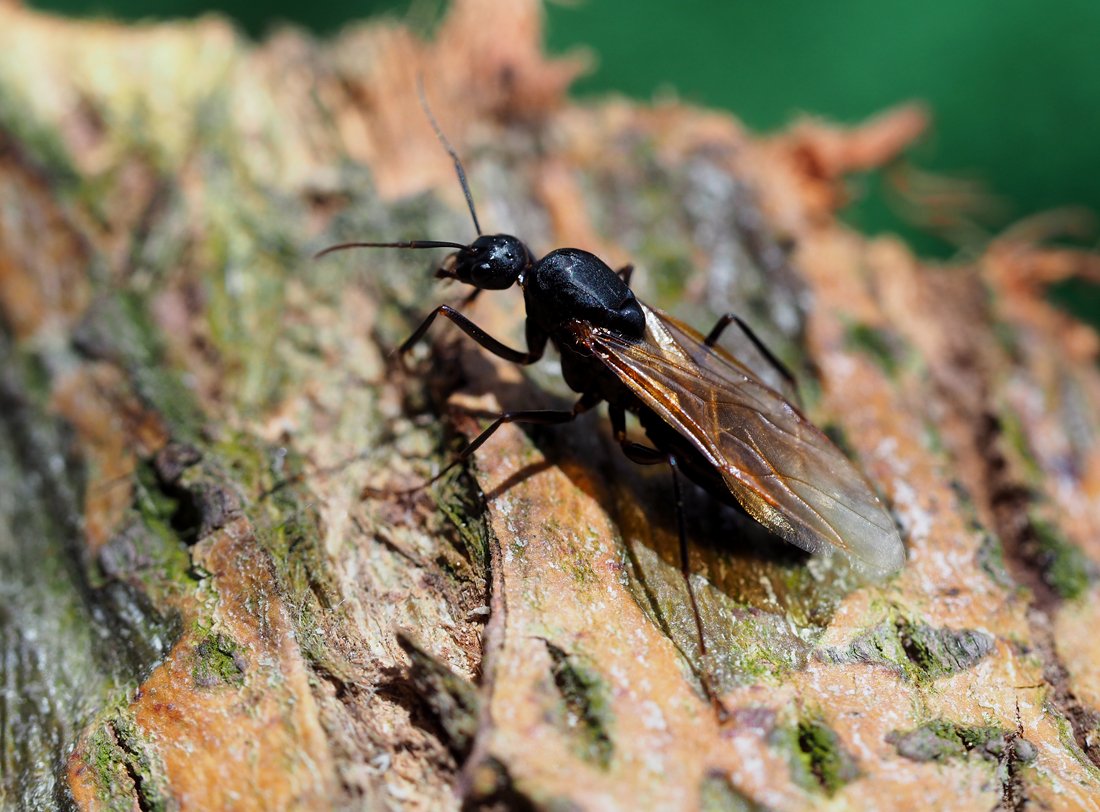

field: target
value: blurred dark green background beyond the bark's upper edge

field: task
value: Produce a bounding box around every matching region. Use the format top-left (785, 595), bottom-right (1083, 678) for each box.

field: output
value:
top-left (21, 0), bottom-right (1100, 320)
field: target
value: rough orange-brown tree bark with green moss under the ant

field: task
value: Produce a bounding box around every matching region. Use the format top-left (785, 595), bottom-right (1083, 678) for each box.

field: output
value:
top-left (0, 0), bottom-right (1100, 810)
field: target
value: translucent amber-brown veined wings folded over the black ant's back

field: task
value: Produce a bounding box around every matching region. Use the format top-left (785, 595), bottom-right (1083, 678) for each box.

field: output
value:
top-left (574, 308), bottom-right (904, 574)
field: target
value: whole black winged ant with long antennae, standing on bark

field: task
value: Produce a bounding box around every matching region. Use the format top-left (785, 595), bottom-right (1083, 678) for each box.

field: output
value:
top-left (317, 86), bottom-right (904, 712)
